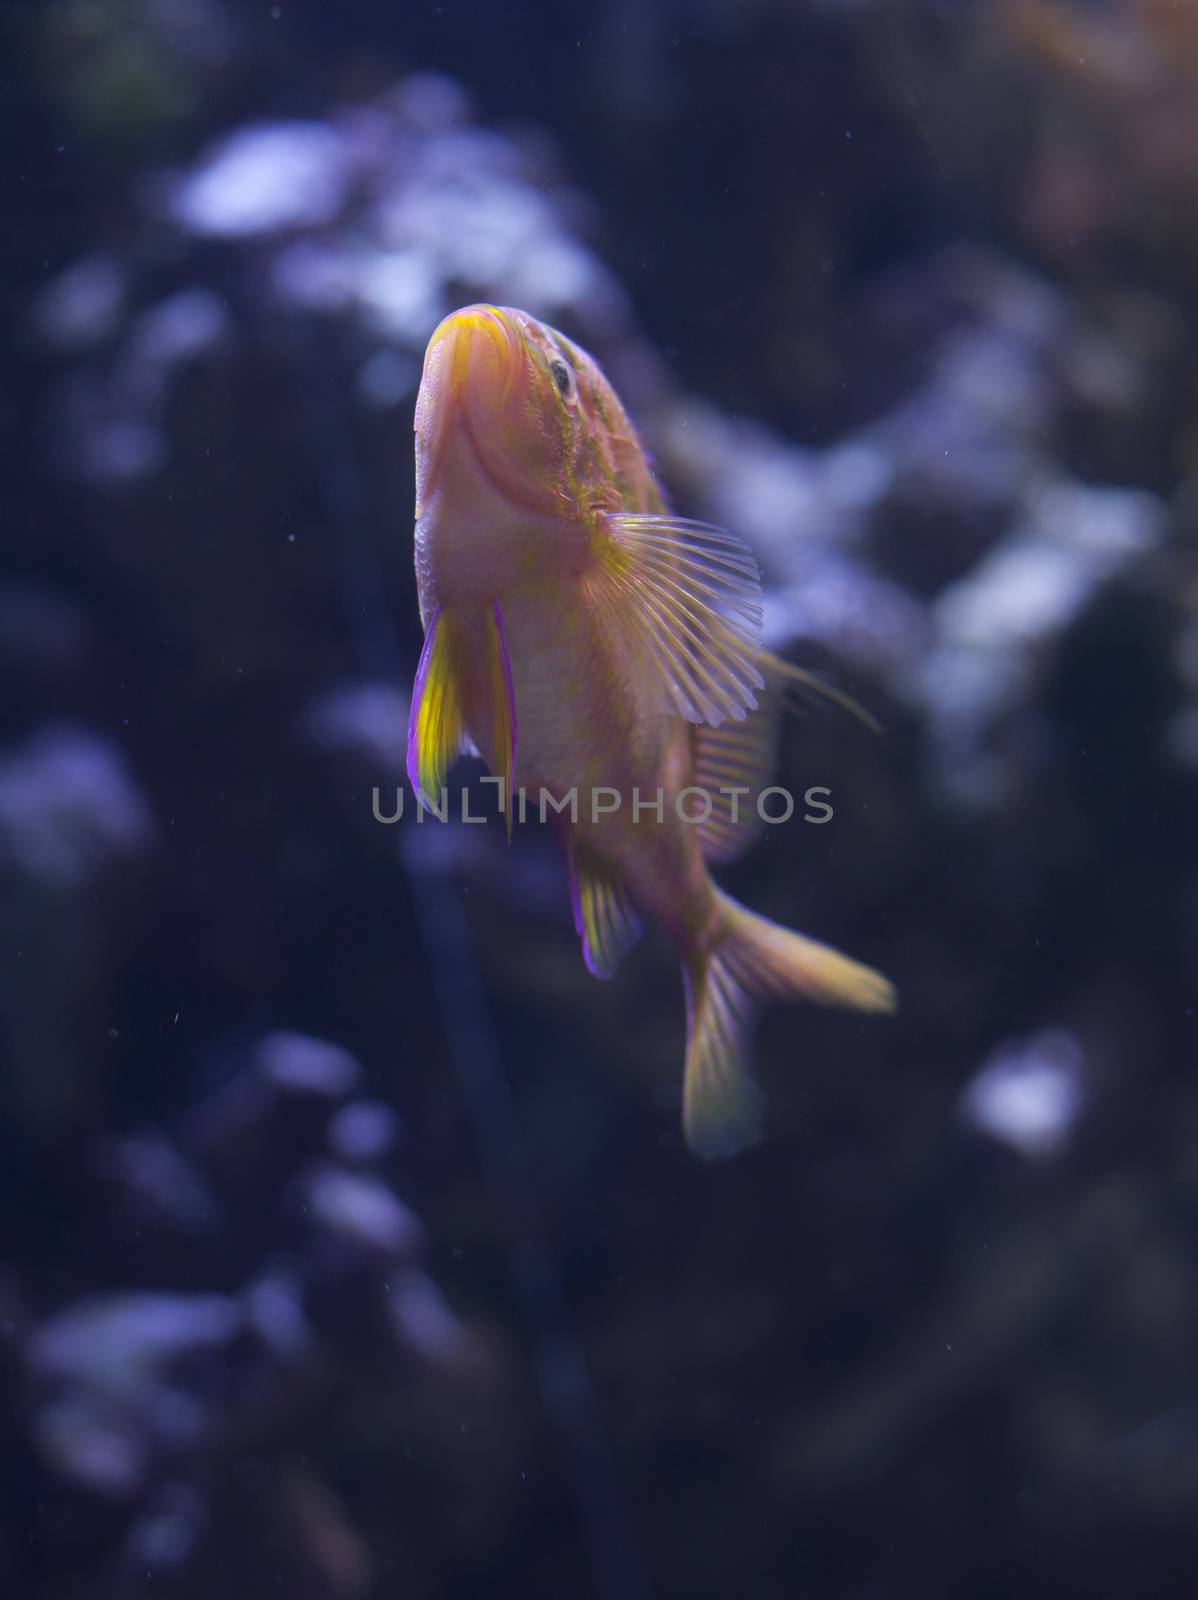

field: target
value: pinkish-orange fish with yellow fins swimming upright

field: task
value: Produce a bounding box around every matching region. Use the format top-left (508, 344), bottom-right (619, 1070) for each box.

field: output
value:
top-left (406, 304), bottom-right (896, 1160)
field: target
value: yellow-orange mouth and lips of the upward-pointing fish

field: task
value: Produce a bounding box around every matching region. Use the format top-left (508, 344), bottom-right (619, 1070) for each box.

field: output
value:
top-left (414, 306), bottom-right (526, 517)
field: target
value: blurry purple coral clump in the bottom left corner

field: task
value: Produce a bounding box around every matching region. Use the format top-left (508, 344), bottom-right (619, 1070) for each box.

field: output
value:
top-left (0, 1035), bottom-right (494, 1597)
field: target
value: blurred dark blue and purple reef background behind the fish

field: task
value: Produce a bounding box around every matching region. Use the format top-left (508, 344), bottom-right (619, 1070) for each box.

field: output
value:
top-left (0, 0), bottom-right (1198, 1600)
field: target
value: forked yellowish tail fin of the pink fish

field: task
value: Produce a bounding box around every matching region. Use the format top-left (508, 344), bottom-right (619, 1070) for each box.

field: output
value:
top-left (683, 890), bottom-right (896, 1160)
